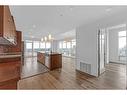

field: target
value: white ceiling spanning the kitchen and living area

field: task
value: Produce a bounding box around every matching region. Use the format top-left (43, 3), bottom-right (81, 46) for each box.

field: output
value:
top-left (10, 6), bottom-right (127, 39)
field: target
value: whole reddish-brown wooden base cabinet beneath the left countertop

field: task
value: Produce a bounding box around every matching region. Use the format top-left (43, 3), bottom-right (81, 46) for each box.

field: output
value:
top-left (0, 61), bottom-right (21, 89)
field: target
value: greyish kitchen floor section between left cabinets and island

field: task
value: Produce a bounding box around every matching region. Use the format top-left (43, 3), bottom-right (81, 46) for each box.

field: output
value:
top-left (21, 57), bottom-right (49, 78)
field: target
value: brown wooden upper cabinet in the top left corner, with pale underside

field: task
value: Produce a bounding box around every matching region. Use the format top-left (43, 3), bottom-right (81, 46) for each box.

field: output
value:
top-left (0, 6), bottom-right (17, 45)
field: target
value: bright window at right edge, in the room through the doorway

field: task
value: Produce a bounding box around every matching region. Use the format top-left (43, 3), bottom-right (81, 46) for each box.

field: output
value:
top-left (118, 31), bottom-right (127, 61)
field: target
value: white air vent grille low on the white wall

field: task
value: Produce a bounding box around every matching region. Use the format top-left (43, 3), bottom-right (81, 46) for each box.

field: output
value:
top-left (80, 62), bottom-right (91, 74)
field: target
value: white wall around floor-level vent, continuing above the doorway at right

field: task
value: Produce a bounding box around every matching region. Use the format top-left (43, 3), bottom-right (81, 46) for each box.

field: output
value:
top-left (76, 11), bottom-right (127, 76)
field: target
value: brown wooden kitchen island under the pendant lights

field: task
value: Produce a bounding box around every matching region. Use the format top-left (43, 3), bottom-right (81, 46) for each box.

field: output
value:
top-left (37, 51), bottom-right (62, 70)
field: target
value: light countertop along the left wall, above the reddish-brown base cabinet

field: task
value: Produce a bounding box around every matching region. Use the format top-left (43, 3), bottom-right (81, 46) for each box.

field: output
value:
top-left (0, 52), bottom-right (21, 58)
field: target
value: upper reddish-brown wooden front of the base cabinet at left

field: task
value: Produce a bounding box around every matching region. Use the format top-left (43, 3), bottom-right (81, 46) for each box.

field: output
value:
top-left (0, 61), bottom-right (21, 82)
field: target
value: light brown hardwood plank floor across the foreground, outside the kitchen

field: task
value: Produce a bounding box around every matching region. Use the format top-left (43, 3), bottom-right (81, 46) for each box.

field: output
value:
top-left (18, 57), bottom-right (126, 90)
